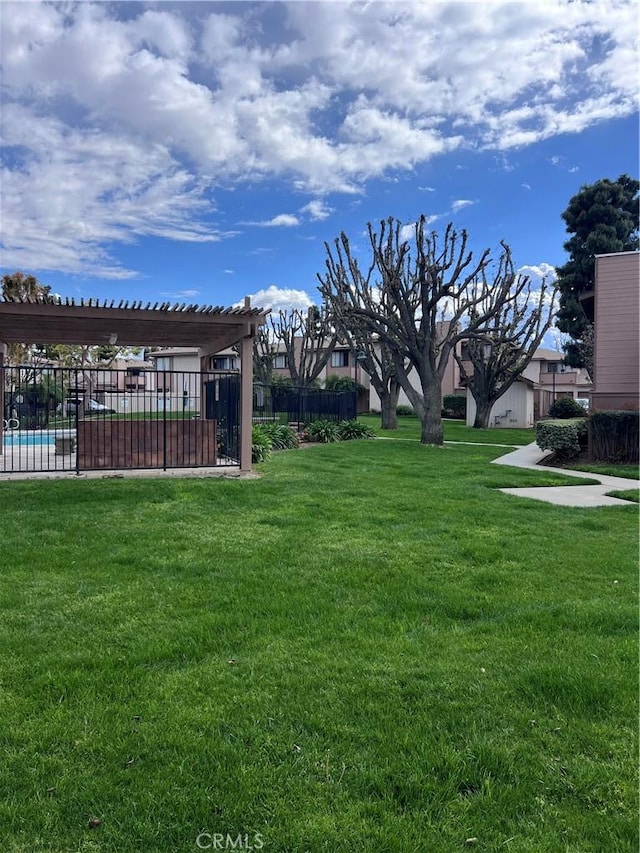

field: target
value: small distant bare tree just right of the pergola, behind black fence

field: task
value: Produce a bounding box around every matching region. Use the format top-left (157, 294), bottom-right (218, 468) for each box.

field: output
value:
top-left (268, 305), bottom-right (338, 388)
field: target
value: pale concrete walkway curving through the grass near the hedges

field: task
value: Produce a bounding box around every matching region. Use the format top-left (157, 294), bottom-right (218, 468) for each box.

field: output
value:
top-left (492, 443), bottom-right (640, 507)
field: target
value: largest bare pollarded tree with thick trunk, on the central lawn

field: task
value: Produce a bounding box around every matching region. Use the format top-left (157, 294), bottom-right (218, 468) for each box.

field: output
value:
top-left (319, 216), bottom-right (524, 444)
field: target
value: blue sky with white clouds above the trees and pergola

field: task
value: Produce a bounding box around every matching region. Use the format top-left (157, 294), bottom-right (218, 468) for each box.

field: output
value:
top-left (0, 0), bottom-right (638, 316)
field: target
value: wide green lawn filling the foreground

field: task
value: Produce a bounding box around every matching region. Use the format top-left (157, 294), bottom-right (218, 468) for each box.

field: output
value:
top-left (0, 441), bottom-right (638, 853)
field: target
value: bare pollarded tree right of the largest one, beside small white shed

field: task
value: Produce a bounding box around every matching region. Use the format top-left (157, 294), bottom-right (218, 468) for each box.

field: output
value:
top-left (454, 264), bottom-right (557, 429)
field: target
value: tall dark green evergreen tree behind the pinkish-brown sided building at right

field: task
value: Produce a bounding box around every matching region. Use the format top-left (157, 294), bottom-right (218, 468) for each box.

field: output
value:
top-left (556, 175), bottom-right (640, 368)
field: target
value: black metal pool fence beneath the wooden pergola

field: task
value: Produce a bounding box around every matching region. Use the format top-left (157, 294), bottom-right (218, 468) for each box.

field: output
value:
top-left (0, 365), bottom-right (240, 473)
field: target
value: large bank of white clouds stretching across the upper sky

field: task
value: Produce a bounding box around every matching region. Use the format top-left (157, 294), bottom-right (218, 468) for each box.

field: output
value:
top-left (0, 0), bottom-right (637, 278)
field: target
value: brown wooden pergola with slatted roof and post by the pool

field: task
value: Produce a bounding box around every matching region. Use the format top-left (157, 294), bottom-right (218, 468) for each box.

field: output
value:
top-left (0, 296), bottom-right (269, 471)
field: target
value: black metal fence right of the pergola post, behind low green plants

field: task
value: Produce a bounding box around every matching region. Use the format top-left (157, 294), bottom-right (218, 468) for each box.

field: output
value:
top-left (253, 385), bottom-right (356, 425)
